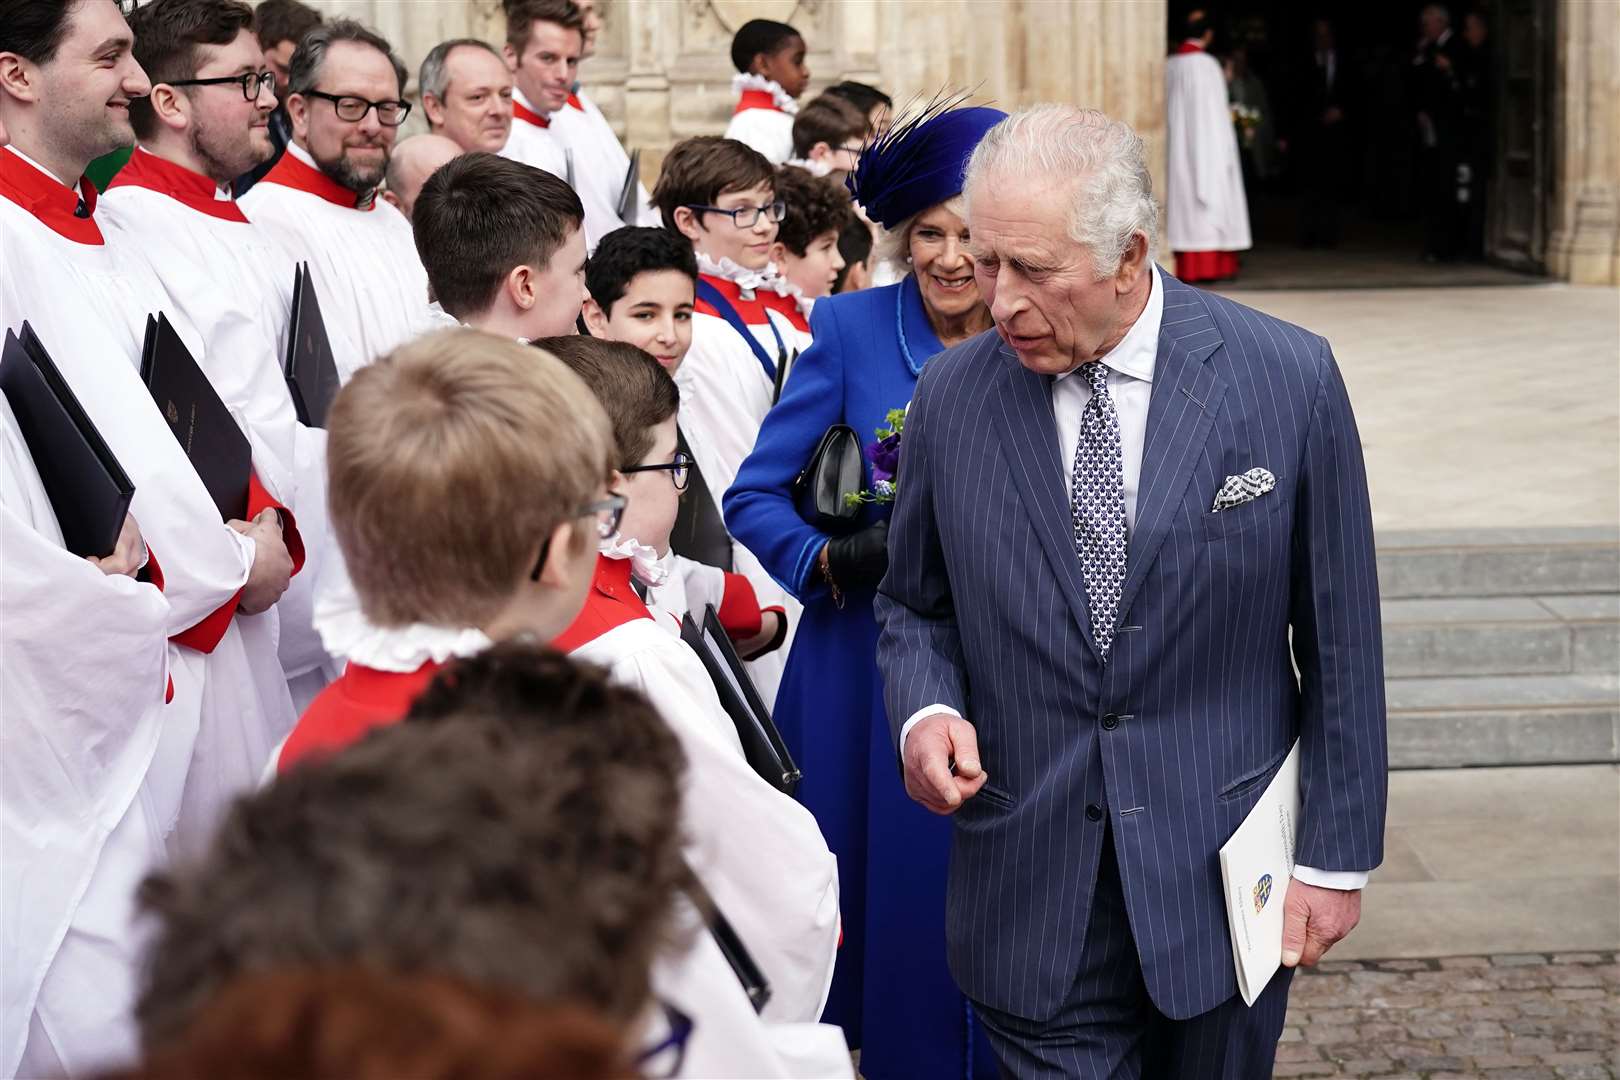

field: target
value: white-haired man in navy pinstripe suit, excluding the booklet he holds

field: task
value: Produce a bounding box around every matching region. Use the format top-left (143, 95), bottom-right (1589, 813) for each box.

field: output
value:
top-left (878, 105), bottom-right (1387, 1080)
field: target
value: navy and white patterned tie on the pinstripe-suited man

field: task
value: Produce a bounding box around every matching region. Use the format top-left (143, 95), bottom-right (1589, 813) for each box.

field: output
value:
top-left (1069, 361), bottom-right (1126, 662)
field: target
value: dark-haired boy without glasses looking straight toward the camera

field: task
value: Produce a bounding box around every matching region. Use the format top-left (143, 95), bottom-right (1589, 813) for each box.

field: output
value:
top-left (585, 227), bottom-right (787, 659)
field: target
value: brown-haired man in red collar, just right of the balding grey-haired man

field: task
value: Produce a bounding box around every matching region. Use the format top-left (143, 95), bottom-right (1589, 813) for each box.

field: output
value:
top-left (501, 0), bottom-right (585, 180)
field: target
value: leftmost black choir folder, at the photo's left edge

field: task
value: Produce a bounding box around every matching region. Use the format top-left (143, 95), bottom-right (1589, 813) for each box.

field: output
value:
top-left (0, 322), bottom-right (134, 559)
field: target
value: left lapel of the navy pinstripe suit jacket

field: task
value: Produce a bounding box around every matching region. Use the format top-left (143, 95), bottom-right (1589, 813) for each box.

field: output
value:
top-left (993, 343), bottom-right (1098, 654)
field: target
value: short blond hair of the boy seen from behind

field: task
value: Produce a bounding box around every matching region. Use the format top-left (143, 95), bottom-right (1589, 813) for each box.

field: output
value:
top-left (327, 329), bottom-right (614, 627)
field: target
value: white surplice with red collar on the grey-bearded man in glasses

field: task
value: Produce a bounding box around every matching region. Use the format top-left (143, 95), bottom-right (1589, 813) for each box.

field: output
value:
top-left (241, 142), bottom-right (428, 375)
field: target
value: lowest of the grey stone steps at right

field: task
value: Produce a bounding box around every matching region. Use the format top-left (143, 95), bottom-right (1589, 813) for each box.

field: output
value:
top-left (1385, 674), bottom-right (1620, 769)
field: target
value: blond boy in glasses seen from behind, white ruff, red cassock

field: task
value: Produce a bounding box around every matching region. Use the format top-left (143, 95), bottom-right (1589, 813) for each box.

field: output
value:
top-left (275, 329), bottom-right (612, 772)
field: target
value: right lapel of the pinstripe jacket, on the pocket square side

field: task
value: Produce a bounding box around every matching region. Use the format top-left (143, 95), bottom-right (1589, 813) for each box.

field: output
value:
top-left (1119, 274), bottom-right (1226, 617)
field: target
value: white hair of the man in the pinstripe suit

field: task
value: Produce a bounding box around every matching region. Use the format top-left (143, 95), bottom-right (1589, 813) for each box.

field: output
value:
top-left (962, 105), bottom-right (1158, 279)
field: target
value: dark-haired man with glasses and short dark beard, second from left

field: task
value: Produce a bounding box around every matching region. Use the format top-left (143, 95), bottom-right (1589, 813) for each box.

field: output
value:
top-left (100, 0), bottom-right (360, 709)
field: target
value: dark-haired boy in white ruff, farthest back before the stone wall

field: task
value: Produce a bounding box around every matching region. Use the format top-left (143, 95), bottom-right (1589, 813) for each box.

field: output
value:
top-left (726, 19), bottom-right (810, 165)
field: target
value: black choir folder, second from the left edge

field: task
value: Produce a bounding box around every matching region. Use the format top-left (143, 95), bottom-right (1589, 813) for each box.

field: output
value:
top-left (141, 314), bottom-right (253, 521)
